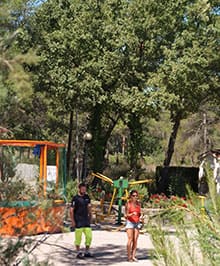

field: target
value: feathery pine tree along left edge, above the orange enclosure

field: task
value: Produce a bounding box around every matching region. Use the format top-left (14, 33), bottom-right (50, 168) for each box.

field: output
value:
top-left (0, 1), bottom-right (37, 135)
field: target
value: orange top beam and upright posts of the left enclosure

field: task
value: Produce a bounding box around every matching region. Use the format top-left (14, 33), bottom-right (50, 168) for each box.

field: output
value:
top-left (0, 140), bottom-right (65, 196)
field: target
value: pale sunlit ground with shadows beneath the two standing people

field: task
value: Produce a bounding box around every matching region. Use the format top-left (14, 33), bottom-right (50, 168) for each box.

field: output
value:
top-left (26, 228), bottom-right (153, 266)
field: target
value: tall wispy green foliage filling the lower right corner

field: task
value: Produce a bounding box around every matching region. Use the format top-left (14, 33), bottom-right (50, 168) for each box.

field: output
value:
top-left (148, 169), bottom-right (220, 266)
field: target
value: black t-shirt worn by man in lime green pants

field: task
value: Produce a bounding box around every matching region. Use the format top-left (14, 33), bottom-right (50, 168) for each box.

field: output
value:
top-left (71, 194), bottom-right (90, 228)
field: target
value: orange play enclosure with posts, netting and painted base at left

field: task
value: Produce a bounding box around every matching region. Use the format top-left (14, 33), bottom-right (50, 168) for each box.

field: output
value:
top-left (0, 140), bottom-right (66, 236)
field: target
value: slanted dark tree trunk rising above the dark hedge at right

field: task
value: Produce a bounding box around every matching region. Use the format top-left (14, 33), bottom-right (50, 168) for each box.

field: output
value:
top-left (163, 113), bottom-right (181, 167)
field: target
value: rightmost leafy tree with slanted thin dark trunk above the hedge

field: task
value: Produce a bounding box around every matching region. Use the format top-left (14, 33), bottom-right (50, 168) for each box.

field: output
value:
top-left (149, 1), bottom-right (219, 166)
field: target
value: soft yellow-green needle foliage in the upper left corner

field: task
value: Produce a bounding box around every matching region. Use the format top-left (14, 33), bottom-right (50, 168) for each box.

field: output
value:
top-left (0, 0), bottom-right (37, 99)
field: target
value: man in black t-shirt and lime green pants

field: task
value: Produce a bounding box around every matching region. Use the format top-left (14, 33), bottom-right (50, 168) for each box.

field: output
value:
top-left (70, 183), bottom-right (92, 259)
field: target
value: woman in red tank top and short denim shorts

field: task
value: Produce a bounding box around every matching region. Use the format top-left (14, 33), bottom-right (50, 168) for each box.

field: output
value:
top-left (125, 190), bottom-right (141, 261)
